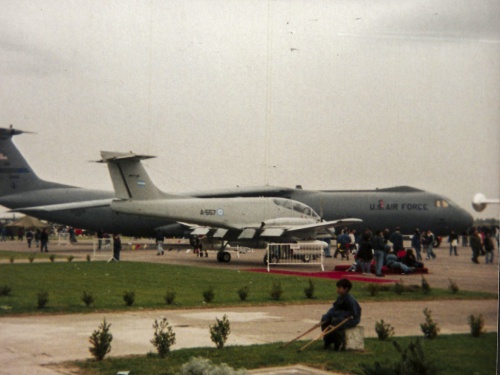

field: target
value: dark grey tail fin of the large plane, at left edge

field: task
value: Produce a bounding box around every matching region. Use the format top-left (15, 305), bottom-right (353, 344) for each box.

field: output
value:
top-left (0, 127), bottom-right (68, 197)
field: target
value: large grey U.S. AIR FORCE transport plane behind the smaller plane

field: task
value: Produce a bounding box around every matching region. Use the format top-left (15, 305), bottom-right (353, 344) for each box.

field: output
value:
top-left (0, 128), bottom-right (473, 251)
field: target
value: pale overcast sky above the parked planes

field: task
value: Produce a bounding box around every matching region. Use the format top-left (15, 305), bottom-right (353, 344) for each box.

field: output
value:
top-left (0, 0), bottom-right (500, 218)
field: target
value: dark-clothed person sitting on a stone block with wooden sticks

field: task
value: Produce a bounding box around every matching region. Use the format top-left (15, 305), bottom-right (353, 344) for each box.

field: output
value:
top-left (321, 279), bottom-right (361, 351)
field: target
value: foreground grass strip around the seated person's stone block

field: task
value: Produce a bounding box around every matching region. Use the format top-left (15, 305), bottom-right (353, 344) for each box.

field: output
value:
top-left (71, 333), bottom-right (497, 375)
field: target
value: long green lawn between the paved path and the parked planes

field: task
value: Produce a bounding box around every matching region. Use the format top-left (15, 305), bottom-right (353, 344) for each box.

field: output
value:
top-left (0, 261), bottom-right (496, 316)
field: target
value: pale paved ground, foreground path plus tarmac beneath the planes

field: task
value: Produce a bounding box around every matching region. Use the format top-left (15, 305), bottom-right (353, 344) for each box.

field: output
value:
top-left (0, 242), bottom-right (499, 375)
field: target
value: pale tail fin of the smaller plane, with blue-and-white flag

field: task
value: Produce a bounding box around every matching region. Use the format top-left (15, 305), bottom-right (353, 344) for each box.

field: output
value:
top-left (101, 151), bottom-right (174, 200)
